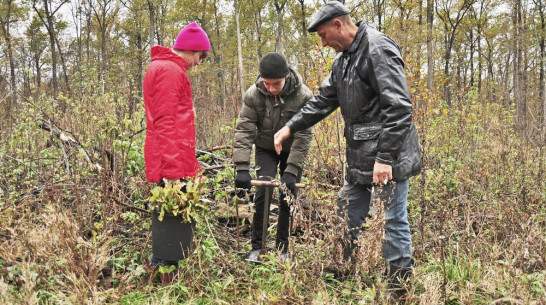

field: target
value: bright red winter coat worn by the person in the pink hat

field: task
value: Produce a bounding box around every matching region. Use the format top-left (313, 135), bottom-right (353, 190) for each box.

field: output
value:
top-left (143, 46), bottom-right (199, 182)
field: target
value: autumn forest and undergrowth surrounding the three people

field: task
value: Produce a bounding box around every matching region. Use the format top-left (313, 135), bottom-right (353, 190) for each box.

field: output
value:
top-left (0, 0), bottom-right (546, 304)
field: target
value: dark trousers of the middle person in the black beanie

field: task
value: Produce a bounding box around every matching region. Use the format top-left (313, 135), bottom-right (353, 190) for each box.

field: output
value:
top-left (252, 147), bottom-right (302, 252)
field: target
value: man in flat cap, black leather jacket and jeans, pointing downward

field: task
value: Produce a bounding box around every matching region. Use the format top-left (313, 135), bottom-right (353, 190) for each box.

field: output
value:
top-left (275, 1), bottom-right (421, 294)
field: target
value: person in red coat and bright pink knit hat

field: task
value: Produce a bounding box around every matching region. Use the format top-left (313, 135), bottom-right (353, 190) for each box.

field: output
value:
top-left (143, 22), bottom-right (210, 274)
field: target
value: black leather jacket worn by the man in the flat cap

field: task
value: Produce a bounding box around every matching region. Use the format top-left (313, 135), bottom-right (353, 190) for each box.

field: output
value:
top-left (286, 22), bottom-right (421, 185)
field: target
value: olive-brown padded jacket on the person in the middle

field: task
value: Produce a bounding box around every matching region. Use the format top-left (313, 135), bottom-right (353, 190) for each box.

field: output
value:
top-left (233, 68), bottom-right (313, 176)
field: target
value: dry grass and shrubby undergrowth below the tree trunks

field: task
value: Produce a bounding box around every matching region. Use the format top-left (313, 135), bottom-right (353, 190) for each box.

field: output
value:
top-left (0, 79), bottom-right (546, 304)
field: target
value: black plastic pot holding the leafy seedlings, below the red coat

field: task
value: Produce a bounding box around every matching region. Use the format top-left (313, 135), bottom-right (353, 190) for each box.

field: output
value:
top-left (152, 212), bottom-right (195, 261)
